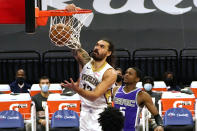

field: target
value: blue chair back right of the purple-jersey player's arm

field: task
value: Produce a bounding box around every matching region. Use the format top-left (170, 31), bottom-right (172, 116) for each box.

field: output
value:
top-left (163, 108), bottom-right (194, 131)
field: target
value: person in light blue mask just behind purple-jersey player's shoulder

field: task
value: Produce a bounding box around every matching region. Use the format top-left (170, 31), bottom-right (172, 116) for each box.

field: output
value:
top-left (142, 76), bottom-right (161, 109)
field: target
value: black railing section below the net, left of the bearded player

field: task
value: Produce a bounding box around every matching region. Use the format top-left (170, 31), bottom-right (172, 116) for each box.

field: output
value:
top-left (42, 50), bottom-right (79, 83)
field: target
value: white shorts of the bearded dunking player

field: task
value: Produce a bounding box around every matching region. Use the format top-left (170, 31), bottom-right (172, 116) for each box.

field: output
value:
top-left (80, 109), bottom-right (103, 131)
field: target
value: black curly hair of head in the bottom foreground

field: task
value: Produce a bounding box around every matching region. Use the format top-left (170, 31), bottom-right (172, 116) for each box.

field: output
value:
top-left (98, 106), bottom-right (124, 131)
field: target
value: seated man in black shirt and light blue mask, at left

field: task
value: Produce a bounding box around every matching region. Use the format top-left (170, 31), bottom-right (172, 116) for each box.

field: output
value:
top-left (32, 76), bottom-right (50, 131)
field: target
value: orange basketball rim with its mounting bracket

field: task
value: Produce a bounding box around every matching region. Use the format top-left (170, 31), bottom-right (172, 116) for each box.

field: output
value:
top-left (35, 7), bottom-right (92, 26)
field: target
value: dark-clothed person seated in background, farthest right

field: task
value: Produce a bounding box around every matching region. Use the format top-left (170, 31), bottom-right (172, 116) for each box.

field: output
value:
top-left (164, 71), bottom-right (181, 91)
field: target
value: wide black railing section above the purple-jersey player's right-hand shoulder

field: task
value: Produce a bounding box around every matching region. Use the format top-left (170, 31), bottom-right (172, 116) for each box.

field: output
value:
top-left (133, 49), bottom-right (178, 80)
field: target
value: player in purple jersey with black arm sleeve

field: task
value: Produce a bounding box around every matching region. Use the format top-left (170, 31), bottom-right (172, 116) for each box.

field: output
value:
top-left (113, 68), bottom-right (163, 131)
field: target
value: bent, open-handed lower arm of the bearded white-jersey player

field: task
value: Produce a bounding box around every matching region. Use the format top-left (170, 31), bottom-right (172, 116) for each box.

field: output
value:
top-left (62, 69), bottom-right (117, 101)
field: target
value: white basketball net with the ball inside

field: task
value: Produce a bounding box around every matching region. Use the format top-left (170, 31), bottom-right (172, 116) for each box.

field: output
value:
top-left (49, 13), bottom-right (91, 49)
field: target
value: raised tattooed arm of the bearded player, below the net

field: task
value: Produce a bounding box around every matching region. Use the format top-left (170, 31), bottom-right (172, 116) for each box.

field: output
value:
top-left (73, 48), bottom-right (91, 68)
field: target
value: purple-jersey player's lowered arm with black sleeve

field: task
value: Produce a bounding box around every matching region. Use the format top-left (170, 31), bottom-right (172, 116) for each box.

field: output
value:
top-left (138, 91), bottom-right (164, 131)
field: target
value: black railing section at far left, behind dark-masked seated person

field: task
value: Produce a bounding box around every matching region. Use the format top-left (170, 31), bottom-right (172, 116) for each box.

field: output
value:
top-left (0, 50), bottom-right (41, 84)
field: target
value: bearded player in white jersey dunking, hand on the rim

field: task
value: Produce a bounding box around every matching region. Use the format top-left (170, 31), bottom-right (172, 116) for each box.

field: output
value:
top-left (62, 4), bottom-right (117, 131)
